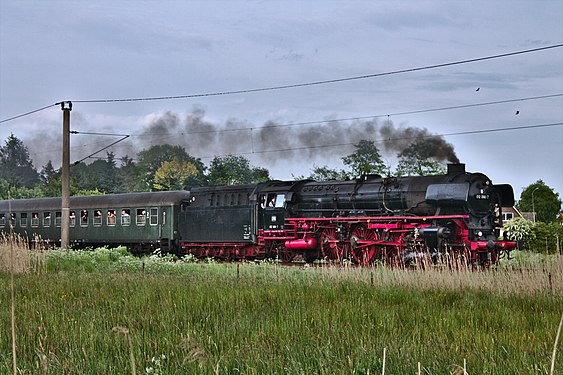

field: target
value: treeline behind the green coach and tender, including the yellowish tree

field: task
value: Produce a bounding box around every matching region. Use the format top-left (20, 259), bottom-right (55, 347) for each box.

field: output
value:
top-left (0, 135), bottom-right (270, 199)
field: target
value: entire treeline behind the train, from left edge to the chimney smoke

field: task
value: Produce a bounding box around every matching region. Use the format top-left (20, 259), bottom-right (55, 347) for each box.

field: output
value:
top-left (0, 134), bottom-right (445, 199)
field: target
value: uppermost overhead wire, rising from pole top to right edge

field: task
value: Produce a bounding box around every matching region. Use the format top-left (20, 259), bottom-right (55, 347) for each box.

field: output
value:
top-left (74, 44), bottom-right (563, 103)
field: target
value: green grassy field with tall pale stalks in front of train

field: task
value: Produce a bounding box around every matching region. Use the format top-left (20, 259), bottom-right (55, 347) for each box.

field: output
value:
top-left (0, 249), bottom-right (563, 374)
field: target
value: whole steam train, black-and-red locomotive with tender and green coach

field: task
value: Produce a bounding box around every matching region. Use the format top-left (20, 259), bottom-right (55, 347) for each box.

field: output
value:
top-left (0, 164), bottom-right (516, 265)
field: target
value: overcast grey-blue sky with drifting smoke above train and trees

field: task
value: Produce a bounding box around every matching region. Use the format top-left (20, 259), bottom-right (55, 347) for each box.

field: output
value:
top-left (0, 0), bottom-right (563, 201)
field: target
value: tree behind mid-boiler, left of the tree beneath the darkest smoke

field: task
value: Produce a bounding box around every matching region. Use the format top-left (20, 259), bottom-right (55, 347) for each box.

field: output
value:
top-left (342, 140), bottom-right (387, 177)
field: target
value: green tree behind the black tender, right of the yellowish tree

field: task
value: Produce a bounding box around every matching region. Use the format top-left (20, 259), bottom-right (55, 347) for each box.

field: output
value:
top-left (207, 155), bottom-right (270, 185)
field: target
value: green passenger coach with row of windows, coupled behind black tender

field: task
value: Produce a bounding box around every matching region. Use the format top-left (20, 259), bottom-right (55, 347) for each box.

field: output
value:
top-left (0, 191), bottom-right (190, 253)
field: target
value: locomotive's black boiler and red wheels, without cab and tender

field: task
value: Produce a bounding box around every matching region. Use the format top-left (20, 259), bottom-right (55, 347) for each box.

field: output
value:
top-left (278, 164), bottom-right (514, 263)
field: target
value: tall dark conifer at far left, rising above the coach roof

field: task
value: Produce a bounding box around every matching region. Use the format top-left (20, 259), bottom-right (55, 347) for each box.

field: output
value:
top-left (0, 134), bottom-right (39, 188)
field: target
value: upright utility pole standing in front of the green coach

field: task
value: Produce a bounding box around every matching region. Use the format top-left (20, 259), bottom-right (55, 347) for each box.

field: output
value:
top-left (61, 101), bottom-right (72, 250)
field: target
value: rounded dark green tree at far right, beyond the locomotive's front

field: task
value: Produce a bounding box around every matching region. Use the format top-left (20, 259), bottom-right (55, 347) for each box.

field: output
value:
top-left (516, 180), bottom-right (561, 223)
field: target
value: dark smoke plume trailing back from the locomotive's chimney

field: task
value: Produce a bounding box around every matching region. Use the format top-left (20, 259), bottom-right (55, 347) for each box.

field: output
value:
top-left (24, 108), bottom-right (459, 168)
